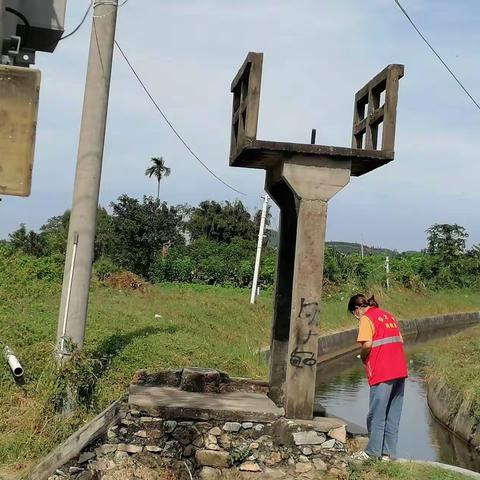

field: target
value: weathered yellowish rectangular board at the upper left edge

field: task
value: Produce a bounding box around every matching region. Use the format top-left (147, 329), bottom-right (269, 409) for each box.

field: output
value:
top-left (0, 65), bottom-right (40, 197)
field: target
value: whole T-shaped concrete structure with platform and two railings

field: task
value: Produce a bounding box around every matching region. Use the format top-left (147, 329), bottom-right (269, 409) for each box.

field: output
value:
top-left (230, 52), bottom-right (404, 419)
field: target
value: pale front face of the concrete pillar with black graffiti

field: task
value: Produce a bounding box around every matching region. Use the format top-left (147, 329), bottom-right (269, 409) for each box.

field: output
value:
top-left (282, 156), bottom-right (351, 419)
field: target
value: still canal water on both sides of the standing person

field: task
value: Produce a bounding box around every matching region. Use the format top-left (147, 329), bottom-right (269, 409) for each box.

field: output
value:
top-left (316, 331), bottom-right (480, 472)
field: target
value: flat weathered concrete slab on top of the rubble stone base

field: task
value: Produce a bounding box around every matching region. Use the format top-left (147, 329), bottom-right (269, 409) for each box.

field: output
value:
top-left (128, 385), bottom-right (284, 422)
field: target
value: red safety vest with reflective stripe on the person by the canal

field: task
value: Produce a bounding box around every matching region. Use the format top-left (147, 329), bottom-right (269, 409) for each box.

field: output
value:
top-left (365, 307), bottom-right (408, 386)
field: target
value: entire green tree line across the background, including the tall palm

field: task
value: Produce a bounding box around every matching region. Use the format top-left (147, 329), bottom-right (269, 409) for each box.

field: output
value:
top-left (0, 157), bottom-right (480, 291)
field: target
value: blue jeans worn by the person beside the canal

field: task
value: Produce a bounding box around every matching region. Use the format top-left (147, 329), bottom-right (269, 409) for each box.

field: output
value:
top-left (365, 378), bottom-right (405, 458)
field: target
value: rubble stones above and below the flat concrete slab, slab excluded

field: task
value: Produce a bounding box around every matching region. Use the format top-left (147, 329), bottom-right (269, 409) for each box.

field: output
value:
top-left (49, 369), bottom-right (365, 480)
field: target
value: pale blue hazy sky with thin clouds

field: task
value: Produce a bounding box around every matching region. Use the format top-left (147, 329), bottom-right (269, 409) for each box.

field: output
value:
top-left (0, 0), bottom-right (480, 251)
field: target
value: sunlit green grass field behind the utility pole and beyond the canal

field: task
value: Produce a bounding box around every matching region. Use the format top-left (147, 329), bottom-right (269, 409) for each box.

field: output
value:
top-left (0, 276), bottom-right (480, 478)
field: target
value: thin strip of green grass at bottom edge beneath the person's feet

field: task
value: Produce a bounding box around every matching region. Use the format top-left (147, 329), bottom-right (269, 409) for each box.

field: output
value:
top-left (349, 462), bottom-right (470, 480)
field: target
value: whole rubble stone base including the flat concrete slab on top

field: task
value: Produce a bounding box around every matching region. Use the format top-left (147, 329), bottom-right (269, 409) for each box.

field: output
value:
top-left (46, 369), bottom-right (368, 480)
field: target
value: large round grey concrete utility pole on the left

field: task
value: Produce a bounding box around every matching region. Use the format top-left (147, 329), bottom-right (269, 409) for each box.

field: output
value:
top-left (56, 0), bottom-right (118, 360)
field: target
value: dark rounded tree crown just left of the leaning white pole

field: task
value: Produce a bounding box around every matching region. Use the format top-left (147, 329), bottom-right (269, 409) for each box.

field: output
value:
top-left (187, 200), bottom-right (257, 243)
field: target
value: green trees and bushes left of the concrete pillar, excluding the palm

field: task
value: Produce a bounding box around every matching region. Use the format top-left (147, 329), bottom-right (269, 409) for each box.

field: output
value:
top-left (3, 195), bottom-right (275, 286)
